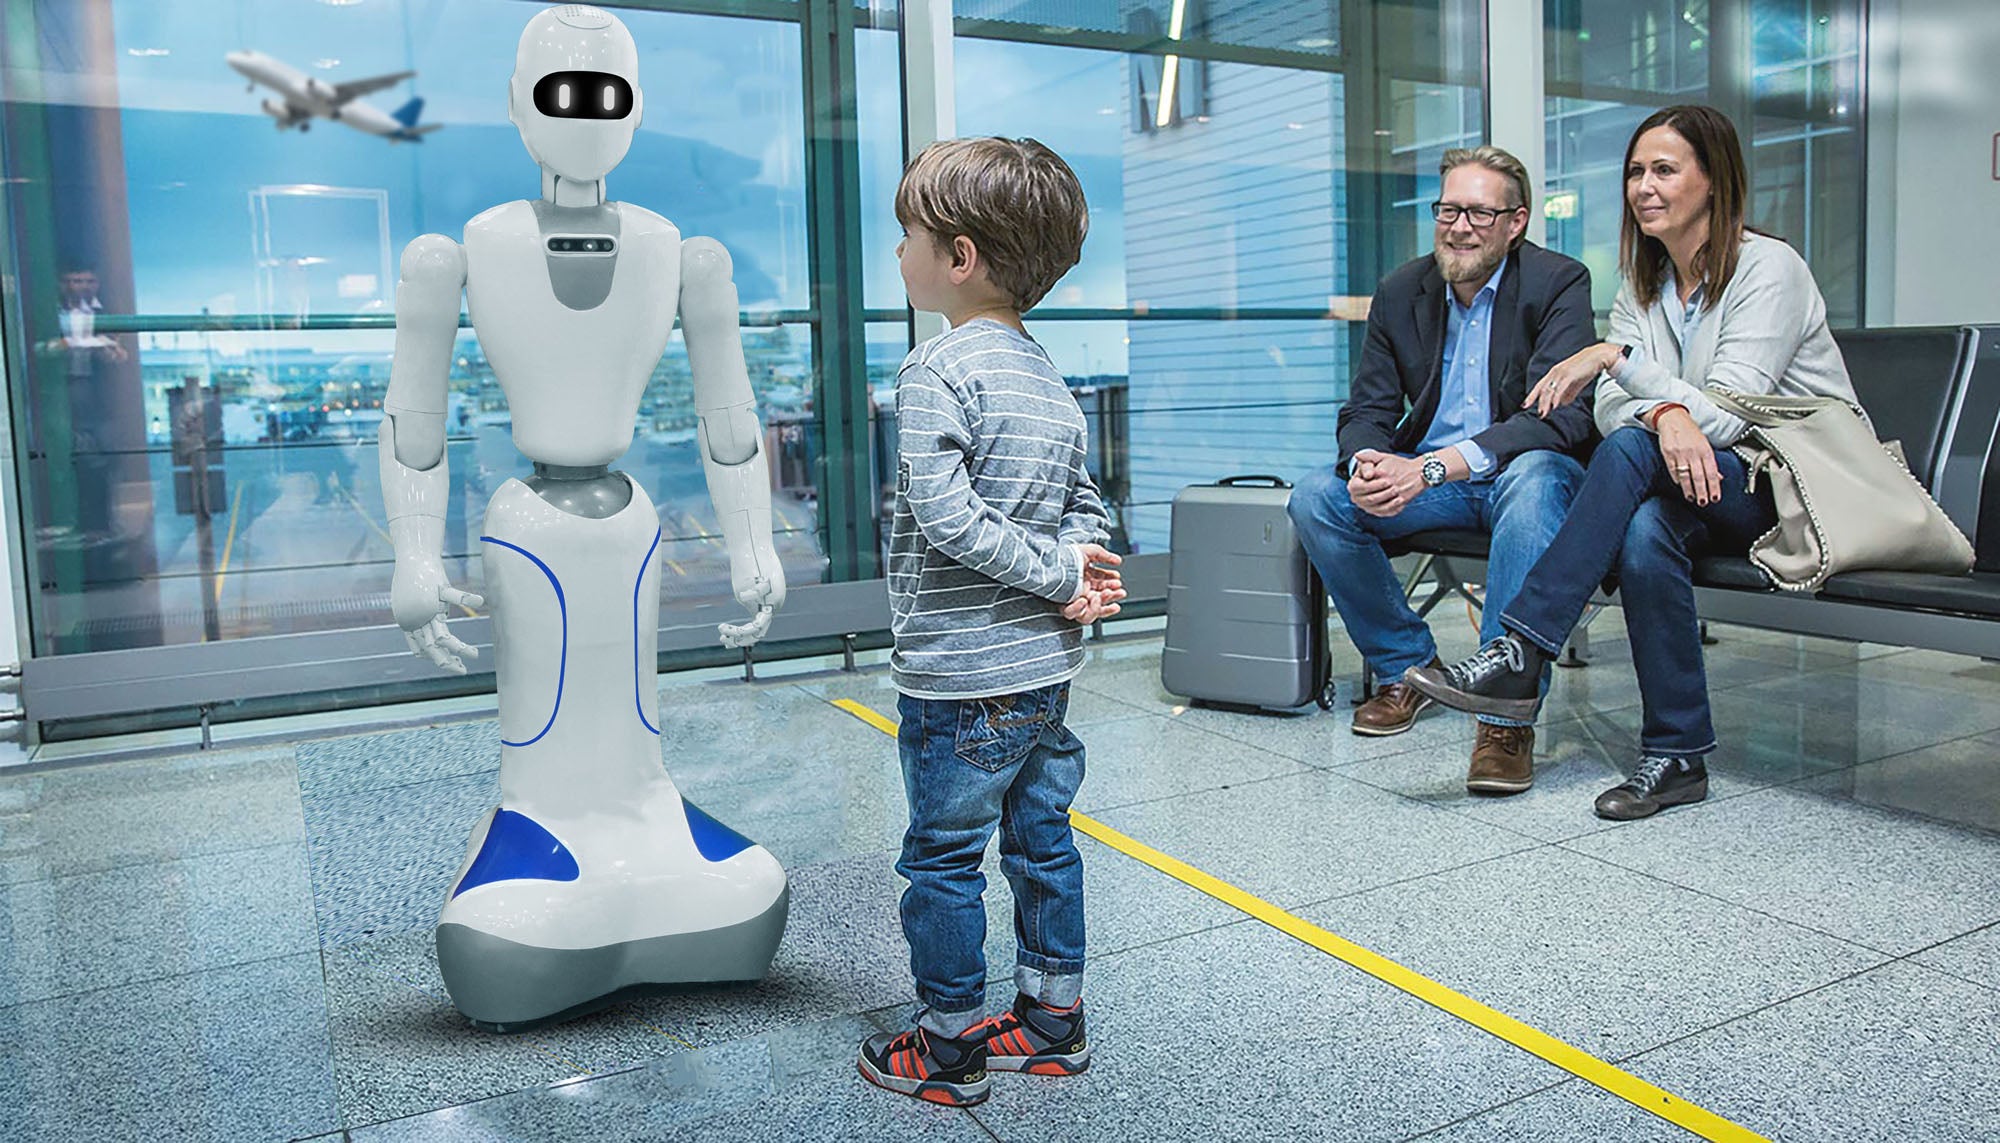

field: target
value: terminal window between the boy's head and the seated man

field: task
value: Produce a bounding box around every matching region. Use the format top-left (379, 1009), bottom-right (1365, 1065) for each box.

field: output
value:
top-left (954, 0), bottom-right (1484, 552)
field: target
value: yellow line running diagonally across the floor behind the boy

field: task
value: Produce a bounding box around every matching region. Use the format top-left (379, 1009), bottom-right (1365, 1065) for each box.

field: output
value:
top-left (834, 699), bottom-right (1770, 1143)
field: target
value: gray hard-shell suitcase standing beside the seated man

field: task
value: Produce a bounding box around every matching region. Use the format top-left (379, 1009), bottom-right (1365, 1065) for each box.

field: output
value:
top-left (1160, 476), bottom-right (1334, 709)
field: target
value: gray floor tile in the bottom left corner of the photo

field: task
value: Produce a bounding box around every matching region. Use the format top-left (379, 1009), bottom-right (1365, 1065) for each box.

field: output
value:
top-left (0, 953), bottom-right (340, 1143)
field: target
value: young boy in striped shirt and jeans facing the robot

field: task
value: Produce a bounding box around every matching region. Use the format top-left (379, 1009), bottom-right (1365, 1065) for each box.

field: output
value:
top-left (860, 138), bottom-right (1124, 1107)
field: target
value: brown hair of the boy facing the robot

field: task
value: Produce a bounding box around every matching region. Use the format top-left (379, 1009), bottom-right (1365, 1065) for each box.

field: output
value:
top-left (896, 138), bottom-right (1090, 312)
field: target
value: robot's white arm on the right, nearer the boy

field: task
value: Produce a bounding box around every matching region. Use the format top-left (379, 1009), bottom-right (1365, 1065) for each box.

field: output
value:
top-left (680, 238), bottom-right (784, 647)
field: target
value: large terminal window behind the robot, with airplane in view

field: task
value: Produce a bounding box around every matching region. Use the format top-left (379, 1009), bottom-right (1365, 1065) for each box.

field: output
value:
top-left (6, 0), bottom-right (824, 653)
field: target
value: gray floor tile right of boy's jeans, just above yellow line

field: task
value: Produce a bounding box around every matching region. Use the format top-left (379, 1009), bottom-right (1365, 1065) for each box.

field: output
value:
top-left (1074, 715), bottom-right (1306, 813)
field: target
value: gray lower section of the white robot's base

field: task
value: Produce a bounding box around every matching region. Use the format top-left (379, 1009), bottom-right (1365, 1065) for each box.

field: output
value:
top-left (438, 885), bottom-right (792, 1033)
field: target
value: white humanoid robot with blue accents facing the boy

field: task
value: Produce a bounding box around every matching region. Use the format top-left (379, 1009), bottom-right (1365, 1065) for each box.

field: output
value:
top-left (380, 4), bottom-right (790, 1031)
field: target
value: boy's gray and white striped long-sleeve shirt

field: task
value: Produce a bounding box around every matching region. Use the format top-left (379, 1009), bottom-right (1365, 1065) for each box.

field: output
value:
top-left (888, 318), bottom-right (1108, 699)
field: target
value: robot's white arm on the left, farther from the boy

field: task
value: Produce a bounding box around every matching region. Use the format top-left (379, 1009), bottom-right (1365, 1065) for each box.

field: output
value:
top-left (380, 234), bottom-right (484, 675)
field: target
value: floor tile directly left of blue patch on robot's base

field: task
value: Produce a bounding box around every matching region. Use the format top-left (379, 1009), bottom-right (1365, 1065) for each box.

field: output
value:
top-left (306, 773), bottom-right (500, 945)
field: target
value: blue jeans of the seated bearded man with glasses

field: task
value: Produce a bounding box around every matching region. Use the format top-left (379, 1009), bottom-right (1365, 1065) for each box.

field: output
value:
top-left (1290, 450), bottom-right (1584, 723)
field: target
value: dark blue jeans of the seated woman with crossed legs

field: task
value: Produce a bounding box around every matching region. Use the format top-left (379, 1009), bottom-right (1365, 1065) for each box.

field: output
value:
top-left (1500, 428), bottom-right (1778, 757)
